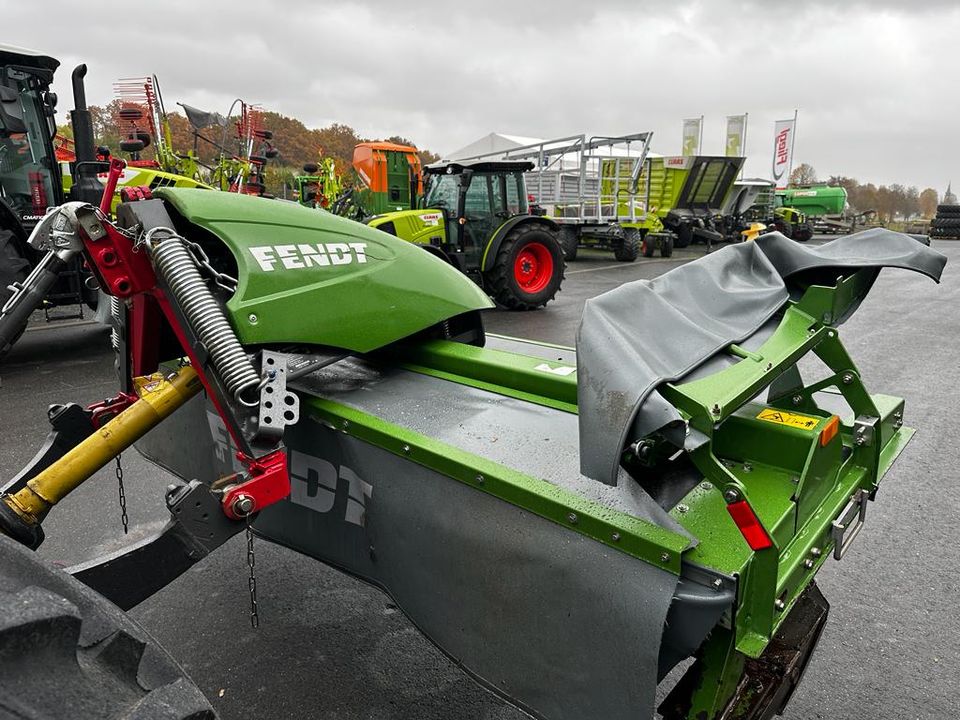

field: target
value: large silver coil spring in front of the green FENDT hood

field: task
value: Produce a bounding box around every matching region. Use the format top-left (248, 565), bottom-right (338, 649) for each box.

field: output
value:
top-left (148, 235), bottom-right (260, 407)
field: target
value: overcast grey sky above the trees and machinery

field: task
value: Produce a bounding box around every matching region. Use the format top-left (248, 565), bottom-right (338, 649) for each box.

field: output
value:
top-left (9, 0), bottom-right (960, 193)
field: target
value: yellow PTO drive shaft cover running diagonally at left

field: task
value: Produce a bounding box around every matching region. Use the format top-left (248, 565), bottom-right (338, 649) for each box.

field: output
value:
top-left (0, 366), bottom-right (203, 544)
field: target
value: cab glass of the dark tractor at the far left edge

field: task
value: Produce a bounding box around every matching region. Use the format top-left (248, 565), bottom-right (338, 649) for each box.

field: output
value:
top-left (0, 68), bottom-right (59, 221)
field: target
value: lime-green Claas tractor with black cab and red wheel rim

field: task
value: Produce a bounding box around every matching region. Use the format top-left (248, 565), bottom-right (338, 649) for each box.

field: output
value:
top-left (366, 161), bottom-right (564, 310)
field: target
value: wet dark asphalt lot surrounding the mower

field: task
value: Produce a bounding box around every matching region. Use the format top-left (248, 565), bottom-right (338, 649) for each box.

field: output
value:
top-left (0, 242), bottom-right (960, 720)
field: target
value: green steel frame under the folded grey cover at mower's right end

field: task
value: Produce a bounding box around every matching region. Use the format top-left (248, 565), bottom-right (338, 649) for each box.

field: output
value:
top-left (660, 271), bottom-right (912, 657)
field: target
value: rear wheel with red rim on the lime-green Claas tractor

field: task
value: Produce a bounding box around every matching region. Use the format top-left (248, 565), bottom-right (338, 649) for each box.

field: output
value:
top-left (484, 221), bottom-right (564, 310)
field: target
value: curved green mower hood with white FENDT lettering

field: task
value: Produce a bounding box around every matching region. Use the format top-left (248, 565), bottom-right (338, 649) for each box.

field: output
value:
top-left (155, 188), bottom-right (493, 352)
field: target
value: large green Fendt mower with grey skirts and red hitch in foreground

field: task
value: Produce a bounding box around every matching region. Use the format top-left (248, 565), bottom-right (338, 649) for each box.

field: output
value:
top-left (0, 184), bottom-right (945, 720)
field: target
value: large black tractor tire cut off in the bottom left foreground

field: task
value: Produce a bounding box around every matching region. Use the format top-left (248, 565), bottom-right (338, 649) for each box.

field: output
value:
top-left (0, 536), bottom-right (217, 720)
